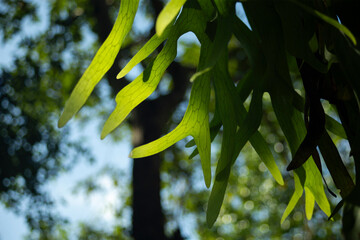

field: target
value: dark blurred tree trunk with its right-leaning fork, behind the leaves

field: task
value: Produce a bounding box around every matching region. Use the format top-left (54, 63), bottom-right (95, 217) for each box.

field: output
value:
top-left (132, 63), bottom-right (188, 240)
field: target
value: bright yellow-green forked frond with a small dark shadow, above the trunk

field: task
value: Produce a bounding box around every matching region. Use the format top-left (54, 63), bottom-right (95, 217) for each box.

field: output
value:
top-left (101, 2), bottom-right (208, 138)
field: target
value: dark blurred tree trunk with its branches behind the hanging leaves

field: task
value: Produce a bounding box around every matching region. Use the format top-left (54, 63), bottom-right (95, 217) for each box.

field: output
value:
top-left (91, 0), bottom-right (188, 240)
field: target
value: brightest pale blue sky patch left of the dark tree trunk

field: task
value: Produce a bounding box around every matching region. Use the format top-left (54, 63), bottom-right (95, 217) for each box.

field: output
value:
top-left (0, 117), bottom-right (131, 239)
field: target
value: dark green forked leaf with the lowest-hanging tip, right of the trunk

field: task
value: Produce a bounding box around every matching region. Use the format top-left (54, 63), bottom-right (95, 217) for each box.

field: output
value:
top-left (207, 50), bottom-right (283, 226)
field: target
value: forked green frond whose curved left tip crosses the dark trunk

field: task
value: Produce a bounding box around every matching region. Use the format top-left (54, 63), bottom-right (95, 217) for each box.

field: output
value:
top-left (130, 3), bottom-right (211, 187)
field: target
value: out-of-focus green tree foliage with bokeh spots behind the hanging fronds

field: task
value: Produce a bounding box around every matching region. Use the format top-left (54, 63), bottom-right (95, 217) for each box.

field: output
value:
top-left (0, 0), bottom-right (353, 240)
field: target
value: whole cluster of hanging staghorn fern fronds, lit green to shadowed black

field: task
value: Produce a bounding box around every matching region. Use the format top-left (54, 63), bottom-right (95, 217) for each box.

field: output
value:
top-left (59, 0), bottom-right (360, 232)
